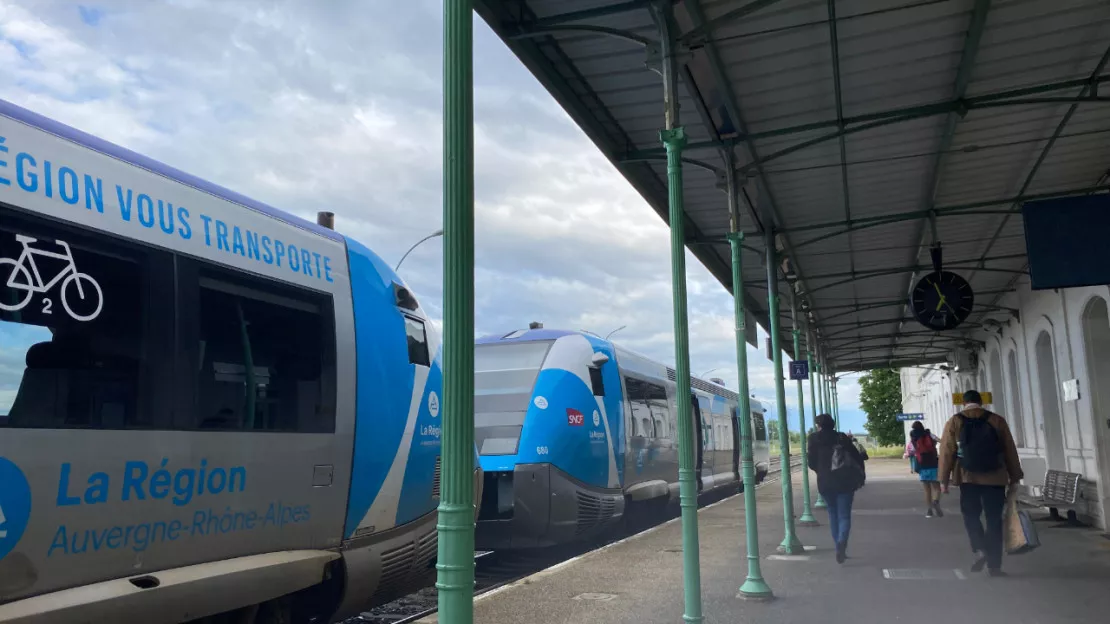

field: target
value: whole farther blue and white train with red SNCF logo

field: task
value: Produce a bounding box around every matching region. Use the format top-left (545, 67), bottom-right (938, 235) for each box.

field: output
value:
top-left (474, 326), bottom-right (768, 550)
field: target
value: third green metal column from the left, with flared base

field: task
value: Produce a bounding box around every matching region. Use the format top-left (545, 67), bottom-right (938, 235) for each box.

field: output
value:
top-left (726, 164), bottom-right (775, 600)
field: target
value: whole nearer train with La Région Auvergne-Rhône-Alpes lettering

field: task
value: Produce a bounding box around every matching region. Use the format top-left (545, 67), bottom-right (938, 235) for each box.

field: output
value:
top-left (0, 102), bottom-right (481, 623)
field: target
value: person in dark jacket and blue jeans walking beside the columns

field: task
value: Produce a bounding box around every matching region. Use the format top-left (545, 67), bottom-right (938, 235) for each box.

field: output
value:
top-left (808, 414), bottom-right (864, 563)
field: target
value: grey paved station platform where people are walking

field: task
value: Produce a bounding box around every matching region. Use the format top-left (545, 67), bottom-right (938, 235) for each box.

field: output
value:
top-left (420, 460), bottom-right (1110, 624)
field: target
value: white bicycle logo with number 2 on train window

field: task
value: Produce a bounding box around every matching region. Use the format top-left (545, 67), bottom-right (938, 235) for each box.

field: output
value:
top-left (0, 234), bottom-right (104, 321)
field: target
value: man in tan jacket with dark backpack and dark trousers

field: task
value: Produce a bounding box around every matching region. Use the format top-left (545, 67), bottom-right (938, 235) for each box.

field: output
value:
top-left (939, 390), bottom-right (1025, 576)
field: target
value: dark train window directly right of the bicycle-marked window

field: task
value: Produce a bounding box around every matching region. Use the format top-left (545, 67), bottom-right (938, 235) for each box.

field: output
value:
top-left (194, 275), bottom-right (335, 433)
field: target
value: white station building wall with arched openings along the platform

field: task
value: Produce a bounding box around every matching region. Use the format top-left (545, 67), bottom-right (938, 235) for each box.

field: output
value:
top-left (901, 279), bottom-right (1110, 529)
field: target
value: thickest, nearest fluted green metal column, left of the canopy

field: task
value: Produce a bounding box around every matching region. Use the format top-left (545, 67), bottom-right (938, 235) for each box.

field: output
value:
top-left (435, 0), bottom-right (474, 624)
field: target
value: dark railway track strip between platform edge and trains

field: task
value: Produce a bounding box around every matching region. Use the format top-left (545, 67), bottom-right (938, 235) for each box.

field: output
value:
top-left (343, 456), bottom-right (801, 624)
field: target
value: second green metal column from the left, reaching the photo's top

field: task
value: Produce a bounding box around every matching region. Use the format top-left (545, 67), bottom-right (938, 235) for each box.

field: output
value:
top-left (652, 0), bottom-right (702, 623)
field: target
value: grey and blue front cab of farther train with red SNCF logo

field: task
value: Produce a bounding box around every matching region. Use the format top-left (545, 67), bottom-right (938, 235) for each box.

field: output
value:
top-left (475, 330), bottom-right (625, 550)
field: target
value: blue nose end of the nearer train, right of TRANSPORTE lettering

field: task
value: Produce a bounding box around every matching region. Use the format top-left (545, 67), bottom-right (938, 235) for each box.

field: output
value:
top-left (328, 240), bottom-right (482, 616)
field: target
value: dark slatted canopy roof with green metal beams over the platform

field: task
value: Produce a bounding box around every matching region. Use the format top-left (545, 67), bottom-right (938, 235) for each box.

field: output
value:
top-left (475, 0), bottom-right (1110, 371)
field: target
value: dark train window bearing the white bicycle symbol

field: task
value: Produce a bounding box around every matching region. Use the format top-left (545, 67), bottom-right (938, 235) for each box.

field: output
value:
top-left (0, 207), bottom-right (173, 429)
